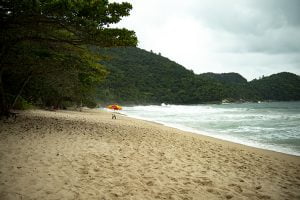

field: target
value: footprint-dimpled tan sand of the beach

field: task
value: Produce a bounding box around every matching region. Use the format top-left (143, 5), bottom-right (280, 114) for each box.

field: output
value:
top-left (0, 110), bottom-right (300, 200)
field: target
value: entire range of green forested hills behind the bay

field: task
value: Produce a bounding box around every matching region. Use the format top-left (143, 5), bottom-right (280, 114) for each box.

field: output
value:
top-left (97, 47), bottom-right (300, 104)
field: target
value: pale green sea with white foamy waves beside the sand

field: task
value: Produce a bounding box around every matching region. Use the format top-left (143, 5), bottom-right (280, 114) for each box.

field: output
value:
top-left (114, 102), bottom-right (300, 156)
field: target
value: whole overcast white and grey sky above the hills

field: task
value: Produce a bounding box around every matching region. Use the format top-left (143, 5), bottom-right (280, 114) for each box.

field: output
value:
top-left (110, 0), bottom-right (300, 81)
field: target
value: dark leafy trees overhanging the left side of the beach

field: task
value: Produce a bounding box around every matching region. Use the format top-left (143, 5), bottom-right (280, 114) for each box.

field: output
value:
top-left (0, 0), bottom-right (137, 115)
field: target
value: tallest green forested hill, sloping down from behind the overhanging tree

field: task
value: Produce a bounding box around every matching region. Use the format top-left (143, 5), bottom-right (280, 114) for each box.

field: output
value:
top-left (95, 48), bottom-right (227, 104)
